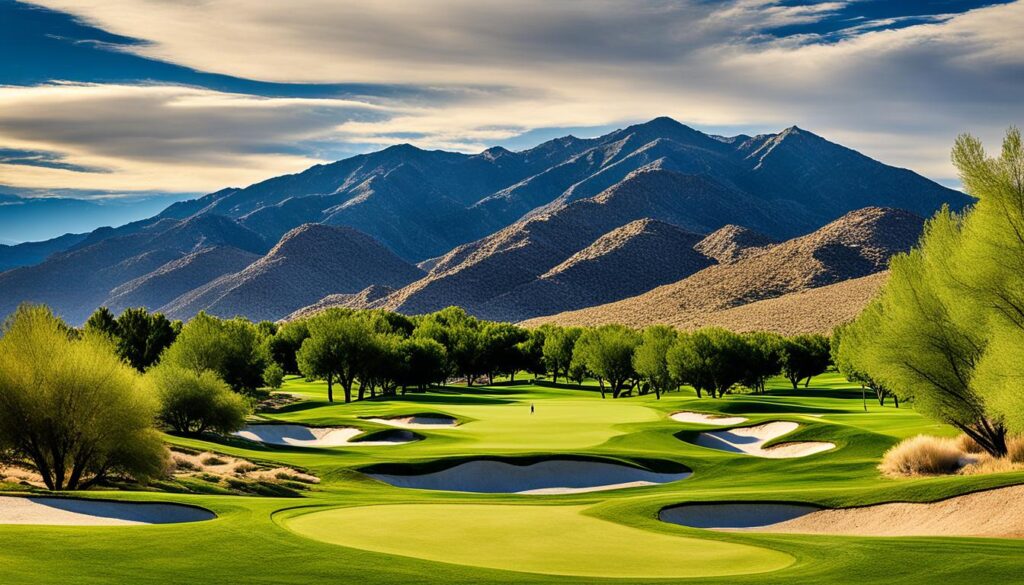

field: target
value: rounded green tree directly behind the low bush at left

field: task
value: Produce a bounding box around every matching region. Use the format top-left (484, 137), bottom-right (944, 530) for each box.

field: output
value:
top-left (164, 312), bottom-right (270, 394)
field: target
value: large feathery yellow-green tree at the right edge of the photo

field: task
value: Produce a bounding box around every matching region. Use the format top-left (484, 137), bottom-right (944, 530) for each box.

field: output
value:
top-left (839, 128), bottom-right (1024, 456)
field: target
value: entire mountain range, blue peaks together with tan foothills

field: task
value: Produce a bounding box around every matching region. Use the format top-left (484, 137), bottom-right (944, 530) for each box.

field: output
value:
top-left (0, 118), bottom-right (971, 325)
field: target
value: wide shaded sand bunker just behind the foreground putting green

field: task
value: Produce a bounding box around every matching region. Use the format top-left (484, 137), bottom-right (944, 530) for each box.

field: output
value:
top-left (368, 459), bottom-right (690, 495)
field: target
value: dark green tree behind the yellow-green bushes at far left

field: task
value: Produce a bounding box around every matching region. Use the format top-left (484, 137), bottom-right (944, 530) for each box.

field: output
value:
top-left (85, 306), bottom-right (181, 372)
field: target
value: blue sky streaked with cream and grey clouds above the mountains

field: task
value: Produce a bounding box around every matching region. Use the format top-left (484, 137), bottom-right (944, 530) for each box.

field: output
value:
top-left (0, 0), bottom-right (1024, 207)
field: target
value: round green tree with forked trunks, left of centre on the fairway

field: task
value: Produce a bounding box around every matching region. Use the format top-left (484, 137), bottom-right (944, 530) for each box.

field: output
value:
top-left (296, 308), bottom-right (373, 403)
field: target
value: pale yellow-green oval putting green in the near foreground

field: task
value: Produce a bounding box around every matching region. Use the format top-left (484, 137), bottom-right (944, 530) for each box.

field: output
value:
top-left (284, 504), bottom-right (795, 579)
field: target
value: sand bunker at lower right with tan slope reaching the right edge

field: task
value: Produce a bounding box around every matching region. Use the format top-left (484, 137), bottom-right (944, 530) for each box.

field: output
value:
top-left (660, 486), bottom-right (1024, 538)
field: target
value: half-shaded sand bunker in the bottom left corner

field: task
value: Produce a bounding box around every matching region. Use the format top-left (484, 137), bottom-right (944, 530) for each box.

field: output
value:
top-left (0, 496), bottom-right (217, 526)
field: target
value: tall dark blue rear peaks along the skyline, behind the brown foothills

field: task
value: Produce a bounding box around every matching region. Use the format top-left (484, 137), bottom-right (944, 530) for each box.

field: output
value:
top-left (132, 118), bottom-right (970, 262)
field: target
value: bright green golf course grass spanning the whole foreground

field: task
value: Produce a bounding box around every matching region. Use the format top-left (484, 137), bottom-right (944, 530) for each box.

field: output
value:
top-left (0, 373), bottom-right (1024, 584)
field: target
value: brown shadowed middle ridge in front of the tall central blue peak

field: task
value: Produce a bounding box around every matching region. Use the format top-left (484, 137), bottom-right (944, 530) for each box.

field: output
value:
top-left (364, 169), bottom-right (780, 320)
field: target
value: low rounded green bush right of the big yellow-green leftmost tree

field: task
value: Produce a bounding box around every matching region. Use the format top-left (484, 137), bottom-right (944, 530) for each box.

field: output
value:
top-left (146, 364), bottom-right (249, 434)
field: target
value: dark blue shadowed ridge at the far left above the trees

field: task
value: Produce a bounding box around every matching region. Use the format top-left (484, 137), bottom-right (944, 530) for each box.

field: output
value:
top-left (0, 215), bottom-right (266, 324)
